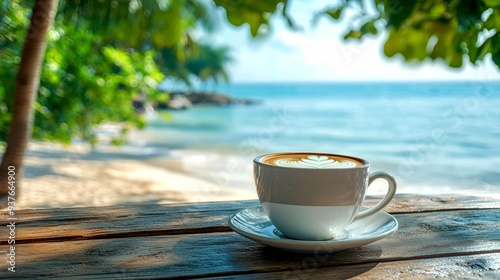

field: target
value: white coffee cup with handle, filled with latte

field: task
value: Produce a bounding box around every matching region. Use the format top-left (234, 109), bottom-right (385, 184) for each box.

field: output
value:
top-left (253, 152), bottom-right (396, 240)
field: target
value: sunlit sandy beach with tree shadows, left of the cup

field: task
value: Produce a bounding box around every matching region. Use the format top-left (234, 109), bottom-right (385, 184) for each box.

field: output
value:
top-left (17, 142), bottom-right (257, 209)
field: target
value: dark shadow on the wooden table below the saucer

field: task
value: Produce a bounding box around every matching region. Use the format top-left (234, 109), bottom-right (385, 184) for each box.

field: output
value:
top-left (168, 234), bottom-right (382, 279)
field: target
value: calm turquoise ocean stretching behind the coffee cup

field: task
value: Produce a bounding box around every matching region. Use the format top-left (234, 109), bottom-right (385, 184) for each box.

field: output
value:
top-left (130, 82), bottom-right (500, 195)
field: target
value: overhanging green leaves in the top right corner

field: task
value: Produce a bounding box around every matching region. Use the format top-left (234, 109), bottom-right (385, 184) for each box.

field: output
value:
top-left (316, 0), bottom-right (500, 68)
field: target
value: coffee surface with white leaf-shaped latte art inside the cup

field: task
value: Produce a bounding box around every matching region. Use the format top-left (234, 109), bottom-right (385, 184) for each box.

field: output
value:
top-left (260, 154), bottom-right (363, 169)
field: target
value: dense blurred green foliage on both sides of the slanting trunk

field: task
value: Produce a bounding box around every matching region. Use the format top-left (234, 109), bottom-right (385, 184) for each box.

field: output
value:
top-left (0, 0), bottom-right (228, 144)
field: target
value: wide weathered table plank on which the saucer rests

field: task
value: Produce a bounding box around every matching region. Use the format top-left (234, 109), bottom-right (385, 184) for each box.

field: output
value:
top-left (0, 209), bottom-right (500, 278)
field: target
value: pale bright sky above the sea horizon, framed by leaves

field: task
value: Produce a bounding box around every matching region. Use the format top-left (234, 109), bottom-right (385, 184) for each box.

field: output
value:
top-left (206, 0), bottom-right (500, 83)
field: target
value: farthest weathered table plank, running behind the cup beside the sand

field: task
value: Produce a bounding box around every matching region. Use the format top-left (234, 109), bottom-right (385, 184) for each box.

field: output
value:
top-left (0, 195), bottom-right (500, 244)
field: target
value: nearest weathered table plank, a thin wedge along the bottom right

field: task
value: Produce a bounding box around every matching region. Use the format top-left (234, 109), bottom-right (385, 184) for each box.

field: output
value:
top-left (208, 253), bottom-right (500, 280)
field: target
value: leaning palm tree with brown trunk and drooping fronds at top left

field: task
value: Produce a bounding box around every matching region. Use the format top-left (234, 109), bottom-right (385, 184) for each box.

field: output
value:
top-left (0, 0), bottom-right (219, 208)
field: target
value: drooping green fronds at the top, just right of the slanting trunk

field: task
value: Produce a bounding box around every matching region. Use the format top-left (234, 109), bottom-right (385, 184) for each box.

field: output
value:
top-left (59, 0), bottom-right (213, 50)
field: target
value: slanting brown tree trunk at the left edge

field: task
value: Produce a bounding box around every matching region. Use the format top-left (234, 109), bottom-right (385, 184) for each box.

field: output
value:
top-left (0, 0), bottom-right (58, 208)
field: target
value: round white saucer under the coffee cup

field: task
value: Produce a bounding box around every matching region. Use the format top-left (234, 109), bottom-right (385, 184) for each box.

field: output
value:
top-left (228, 206), bottom-right (398, 253)
